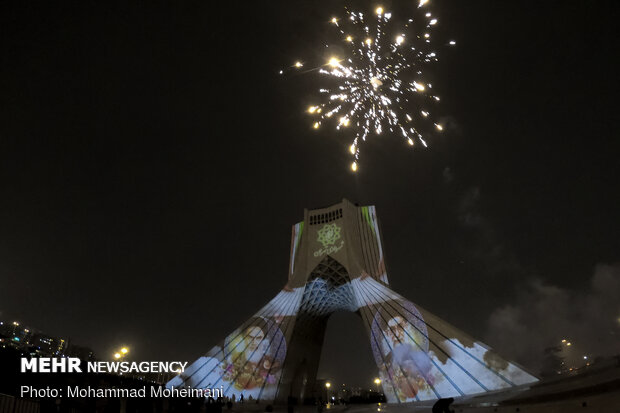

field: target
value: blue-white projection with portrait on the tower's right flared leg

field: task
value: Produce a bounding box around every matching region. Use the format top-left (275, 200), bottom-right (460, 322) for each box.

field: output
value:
top-left (352, 277), bottom-right (537, 403)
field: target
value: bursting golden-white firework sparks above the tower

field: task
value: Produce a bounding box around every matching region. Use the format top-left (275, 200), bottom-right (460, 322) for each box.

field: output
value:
top-left (280, 0), bottom-right (455, 171)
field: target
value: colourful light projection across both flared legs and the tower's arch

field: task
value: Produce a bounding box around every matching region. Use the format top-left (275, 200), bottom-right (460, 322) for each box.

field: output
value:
top-left (169, 270), bottom-right (536, 403)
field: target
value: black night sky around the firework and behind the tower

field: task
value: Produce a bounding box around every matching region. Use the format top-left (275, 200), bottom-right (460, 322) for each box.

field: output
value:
top-left (0, 0), bottom-right (620, 384)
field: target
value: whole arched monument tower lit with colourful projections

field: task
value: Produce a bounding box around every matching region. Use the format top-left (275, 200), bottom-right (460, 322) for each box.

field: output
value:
top-left (167, 200), bottom-right (537, 403)
